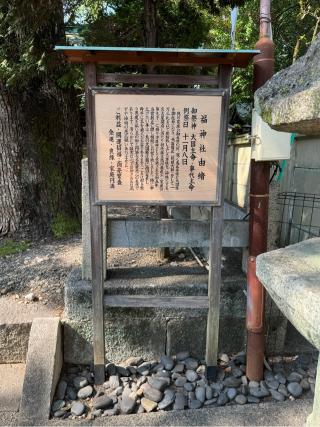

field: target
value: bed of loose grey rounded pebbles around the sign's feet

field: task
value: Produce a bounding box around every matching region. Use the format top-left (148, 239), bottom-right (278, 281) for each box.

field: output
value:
top-left (51, 351), bottom-right (317, 420)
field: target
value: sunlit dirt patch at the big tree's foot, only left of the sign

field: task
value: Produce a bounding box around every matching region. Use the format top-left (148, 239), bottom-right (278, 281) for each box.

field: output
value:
top-left (0, 236), bottom-right (81, 310)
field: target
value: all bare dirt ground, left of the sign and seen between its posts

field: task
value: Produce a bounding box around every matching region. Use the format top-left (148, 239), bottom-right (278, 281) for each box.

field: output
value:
top-left (0, 207), bottom-right (205, 312)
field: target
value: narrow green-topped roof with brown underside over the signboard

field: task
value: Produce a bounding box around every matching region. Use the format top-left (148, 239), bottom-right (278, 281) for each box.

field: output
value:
top-left (55, 46), bottom-right (260, 68)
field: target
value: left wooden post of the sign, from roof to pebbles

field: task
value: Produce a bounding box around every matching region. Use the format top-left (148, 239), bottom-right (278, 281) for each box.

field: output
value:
top-left (85, 63), bottom-right (105, 384)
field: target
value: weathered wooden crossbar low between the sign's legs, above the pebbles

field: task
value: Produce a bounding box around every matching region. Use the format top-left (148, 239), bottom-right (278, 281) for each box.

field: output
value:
top-left (104, 295), bottom-right (208, 308)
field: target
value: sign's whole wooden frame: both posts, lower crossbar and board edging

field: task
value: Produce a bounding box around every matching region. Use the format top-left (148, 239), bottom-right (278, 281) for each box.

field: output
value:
top-left (85, 63), bottom-right (232, 384)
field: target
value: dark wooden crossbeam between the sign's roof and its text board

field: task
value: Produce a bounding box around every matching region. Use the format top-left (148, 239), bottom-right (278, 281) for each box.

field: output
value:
top-left (97, 73), bottom-right (218, 86)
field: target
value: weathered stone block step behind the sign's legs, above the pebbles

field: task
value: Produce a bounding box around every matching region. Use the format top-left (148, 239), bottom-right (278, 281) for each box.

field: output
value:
top-left (63, 270), bottom-right (286, 363)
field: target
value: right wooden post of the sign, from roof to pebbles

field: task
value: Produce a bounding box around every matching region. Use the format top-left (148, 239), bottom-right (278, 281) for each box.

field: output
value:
top-left (206, 66), bottom-right (232, 381)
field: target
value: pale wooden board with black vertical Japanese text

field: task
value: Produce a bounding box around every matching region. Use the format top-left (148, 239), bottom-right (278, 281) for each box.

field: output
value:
top-left (91, 88), bottom-right (225, 205)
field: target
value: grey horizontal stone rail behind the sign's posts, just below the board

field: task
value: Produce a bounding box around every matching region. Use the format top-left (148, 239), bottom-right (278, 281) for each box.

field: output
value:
top-left (107, 218), bottom-right (249, 248)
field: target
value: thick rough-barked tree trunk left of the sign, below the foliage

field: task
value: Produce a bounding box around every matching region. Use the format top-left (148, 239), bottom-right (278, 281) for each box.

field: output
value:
top-left (0, 79), bottom-right (82, 236)
